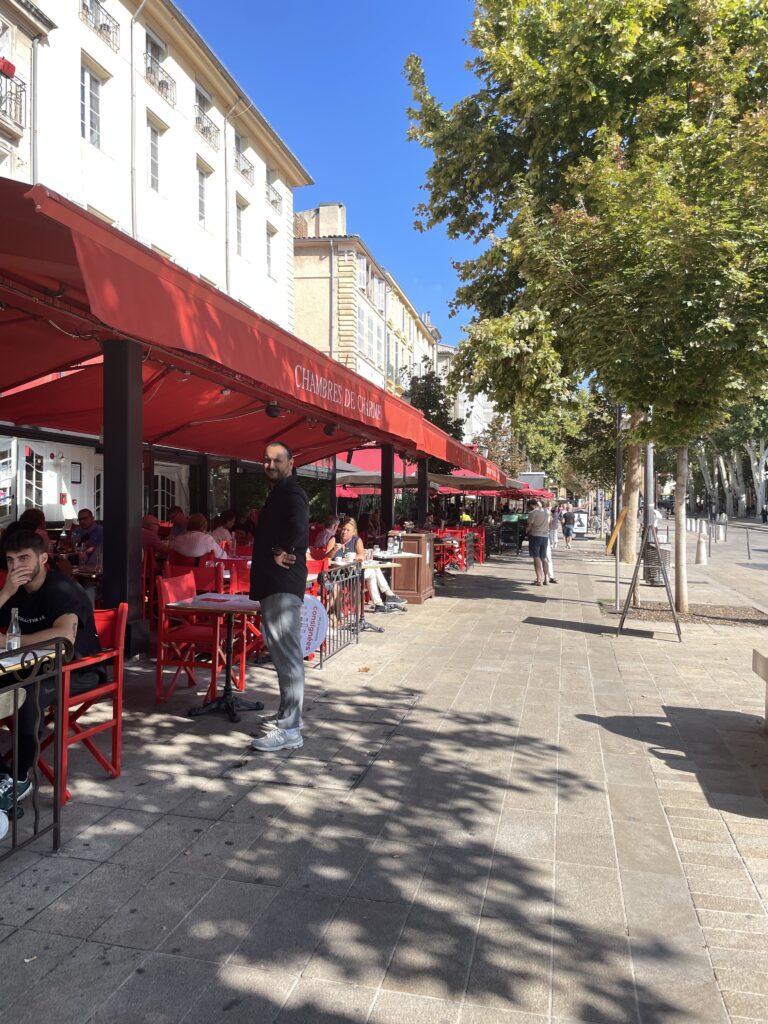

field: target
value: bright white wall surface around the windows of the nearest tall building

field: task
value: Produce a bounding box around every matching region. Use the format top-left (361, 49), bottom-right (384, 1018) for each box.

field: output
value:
top-left (33, 0), bottom-right (303, 330)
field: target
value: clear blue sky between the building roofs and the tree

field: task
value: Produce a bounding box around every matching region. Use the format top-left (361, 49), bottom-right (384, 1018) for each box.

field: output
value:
top-left (176, 0), bottom-right (483, 344)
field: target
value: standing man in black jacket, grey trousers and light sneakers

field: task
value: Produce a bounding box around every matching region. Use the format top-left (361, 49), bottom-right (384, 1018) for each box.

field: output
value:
top-left (251, 441), bottom-right (309, 752)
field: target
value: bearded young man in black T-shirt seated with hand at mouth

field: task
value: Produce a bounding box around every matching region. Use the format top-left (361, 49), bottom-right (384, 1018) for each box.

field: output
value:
top-left (0, 530), bottom-right (103, 813)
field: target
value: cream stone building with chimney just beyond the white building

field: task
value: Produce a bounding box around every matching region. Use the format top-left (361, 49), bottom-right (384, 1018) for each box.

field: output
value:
top-left (294, 203), bottom-right (440, 394)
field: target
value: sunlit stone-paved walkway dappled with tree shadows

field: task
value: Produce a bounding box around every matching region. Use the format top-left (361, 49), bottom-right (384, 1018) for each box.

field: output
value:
top-left (0, 535), bottom-right (768, 1024)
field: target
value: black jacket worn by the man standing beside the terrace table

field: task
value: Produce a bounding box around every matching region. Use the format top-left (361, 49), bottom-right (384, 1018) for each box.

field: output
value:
top-left (251, 476), bottom-right (309, 601)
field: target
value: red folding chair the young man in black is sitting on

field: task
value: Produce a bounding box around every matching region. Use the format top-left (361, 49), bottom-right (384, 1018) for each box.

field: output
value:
top-left (38, 602), bottom-right (128, 804)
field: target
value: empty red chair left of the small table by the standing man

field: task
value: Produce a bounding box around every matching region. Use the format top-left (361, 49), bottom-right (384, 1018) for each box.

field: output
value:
top-left (155, 571), bottom-right (227, 703)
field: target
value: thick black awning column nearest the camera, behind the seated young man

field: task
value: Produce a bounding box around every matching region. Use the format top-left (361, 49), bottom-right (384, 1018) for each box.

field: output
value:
top-left (101, 341), bottom-right (148, 653)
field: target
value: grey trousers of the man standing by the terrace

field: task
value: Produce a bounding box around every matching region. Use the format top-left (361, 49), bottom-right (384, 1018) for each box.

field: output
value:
top-left (261, 594), bottom-right (304, 729)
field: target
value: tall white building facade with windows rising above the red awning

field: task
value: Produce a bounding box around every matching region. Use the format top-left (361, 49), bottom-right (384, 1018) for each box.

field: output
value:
top-left (6, 0), bottom-right (310, 330)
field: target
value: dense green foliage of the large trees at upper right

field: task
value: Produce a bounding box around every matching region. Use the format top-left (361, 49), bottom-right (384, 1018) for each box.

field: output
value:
top-left (407, 0), bottom-right (768, 446)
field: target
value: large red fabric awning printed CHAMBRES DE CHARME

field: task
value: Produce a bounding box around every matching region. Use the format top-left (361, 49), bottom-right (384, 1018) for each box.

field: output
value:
top-left (0, 180), bottom-right (505, 478)
